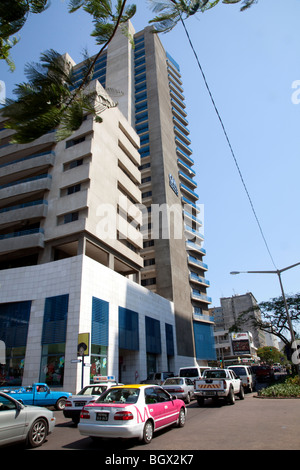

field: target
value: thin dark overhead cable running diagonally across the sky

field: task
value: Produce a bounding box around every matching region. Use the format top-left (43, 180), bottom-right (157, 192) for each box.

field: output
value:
top-left (181, 18), bottom-right (277, 270)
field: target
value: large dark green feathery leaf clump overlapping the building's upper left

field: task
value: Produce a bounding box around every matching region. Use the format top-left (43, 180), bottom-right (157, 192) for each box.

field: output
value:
top-left (2, 50), bottom-right (114, 144)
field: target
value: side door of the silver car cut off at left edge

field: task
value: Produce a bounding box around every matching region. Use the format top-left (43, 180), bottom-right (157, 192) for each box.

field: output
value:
top-left (0, 395), bottom-right (26, 445)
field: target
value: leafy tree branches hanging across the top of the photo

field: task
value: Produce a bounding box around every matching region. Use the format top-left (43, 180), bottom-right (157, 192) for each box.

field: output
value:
top-left (0, 0), bottom-right (257, 144)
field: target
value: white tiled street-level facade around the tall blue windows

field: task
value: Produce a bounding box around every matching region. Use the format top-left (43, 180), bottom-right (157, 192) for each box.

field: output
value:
top-left (0, 255), bottom-right (182, 393)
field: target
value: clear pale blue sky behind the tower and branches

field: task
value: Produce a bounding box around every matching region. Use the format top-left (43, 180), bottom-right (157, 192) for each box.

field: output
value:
top-left (0, 0), bottom-right (300, 312)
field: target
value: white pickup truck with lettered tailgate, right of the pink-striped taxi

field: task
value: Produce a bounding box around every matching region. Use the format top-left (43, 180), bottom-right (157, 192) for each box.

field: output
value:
top-left (195, 369), bottom-right (244, 406)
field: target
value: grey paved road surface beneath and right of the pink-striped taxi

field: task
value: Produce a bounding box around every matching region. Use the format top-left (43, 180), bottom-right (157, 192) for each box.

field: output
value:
top-left (33, 393), bottom-right (300, 453)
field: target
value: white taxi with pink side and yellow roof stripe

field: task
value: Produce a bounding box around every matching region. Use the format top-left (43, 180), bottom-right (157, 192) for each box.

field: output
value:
top-left (78, 385), bottom-right (186, 444)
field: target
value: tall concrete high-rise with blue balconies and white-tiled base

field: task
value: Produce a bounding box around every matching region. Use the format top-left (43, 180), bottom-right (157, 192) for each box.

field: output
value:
top-left (0, 24), bottom-right (215, 391)
